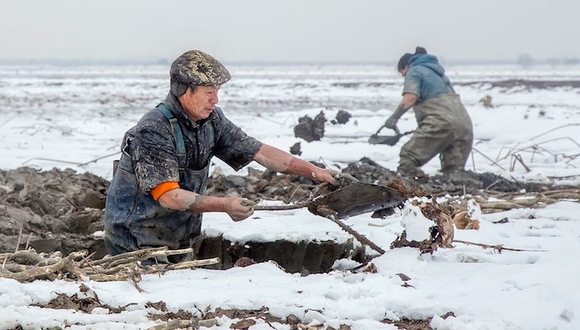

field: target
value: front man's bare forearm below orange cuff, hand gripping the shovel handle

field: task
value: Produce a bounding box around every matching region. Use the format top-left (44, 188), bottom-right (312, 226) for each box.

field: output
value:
top-left (158, 188), bottom-right (254, 221)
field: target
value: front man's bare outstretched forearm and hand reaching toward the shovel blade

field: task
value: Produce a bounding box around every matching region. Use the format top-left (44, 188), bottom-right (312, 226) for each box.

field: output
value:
top-left (254, 144), bottom-right (336, 184)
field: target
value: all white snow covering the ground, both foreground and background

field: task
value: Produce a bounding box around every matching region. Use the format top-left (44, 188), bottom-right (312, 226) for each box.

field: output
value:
top-left (0, 66), bottom-right (580, 330)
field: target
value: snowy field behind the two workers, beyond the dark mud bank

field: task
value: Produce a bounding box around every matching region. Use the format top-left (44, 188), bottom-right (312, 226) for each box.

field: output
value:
top-left (0, 66), bottom-right (580, 183)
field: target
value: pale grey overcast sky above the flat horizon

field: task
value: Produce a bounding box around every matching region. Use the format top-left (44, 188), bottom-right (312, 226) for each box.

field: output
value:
top-left (0, 0), bottom-right (580, 63)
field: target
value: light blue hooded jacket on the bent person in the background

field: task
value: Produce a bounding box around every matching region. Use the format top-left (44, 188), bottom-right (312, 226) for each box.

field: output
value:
top-left (403, 54), bottom-right (455, 103)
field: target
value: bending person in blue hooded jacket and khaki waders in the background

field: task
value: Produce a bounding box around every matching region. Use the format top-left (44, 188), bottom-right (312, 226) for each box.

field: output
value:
top-left (384, 47), bottom-right (473, 182)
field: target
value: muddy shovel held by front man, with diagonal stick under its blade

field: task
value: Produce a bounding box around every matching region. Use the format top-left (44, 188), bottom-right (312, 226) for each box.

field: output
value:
top-left (247, 179), bottom-right (406, 254)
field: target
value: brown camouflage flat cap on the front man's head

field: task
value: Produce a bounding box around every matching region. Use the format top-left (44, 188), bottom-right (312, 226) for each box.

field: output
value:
top-left (169, 50), bottom-right (231, 96)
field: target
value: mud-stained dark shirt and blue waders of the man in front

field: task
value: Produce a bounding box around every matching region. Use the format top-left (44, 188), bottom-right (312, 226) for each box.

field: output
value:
top-left (105, 93), bottom-right (262, 254)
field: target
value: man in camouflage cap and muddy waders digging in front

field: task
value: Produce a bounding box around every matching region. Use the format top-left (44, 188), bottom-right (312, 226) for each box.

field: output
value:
top-left (105, 50), bottom-right (335, 262)
